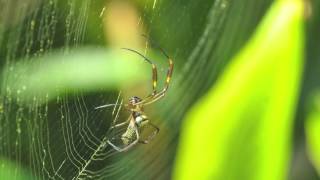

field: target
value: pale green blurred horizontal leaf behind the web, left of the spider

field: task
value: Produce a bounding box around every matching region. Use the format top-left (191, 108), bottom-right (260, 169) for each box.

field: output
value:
top-left (3, 47), bottom-right (148, 102)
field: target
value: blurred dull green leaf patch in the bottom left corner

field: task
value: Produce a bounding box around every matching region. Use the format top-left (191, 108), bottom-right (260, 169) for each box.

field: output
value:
top-left (0, 159), bottom-right (36, 180)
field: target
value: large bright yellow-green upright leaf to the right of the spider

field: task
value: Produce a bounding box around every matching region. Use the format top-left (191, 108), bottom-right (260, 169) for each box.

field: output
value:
top-left (174, 0), bottom-right (304, 180)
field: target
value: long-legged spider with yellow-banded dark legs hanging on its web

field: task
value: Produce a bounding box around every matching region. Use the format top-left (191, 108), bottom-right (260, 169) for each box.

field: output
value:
top-left (96, 44), bottom-right (173, 152)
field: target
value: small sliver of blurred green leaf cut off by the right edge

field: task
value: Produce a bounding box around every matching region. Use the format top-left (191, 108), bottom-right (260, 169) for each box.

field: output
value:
top-left (305, 93), bottom-right (320, 174)
